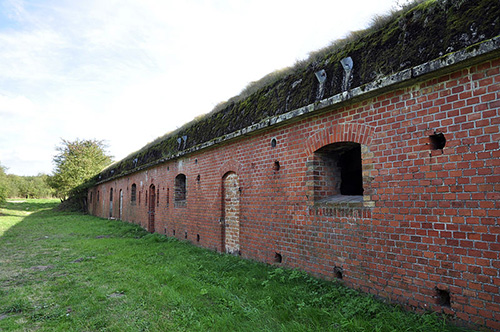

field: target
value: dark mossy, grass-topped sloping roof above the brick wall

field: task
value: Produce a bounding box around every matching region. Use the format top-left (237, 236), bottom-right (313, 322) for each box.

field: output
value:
top-left (98, 0), bottom-right (500, 181)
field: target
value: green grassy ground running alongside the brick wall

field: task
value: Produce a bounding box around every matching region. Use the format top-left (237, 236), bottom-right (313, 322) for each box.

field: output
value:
top-left (0, 200), bottom-right (474, 332)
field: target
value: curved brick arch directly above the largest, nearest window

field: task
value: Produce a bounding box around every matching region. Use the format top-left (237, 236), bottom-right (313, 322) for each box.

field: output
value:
top-left (306, 123), bottom-right (375, 155)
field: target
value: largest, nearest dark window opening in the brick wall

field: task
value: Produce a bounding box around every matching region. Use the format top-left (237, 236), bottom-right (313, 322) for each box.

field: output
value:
top-left (313, 142), bottom-right (364, 200)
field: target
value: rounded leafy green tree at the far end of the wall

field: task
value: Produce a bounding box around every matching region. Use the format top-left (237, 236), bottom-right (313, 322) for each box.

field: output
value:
top-left (49, 139), bottom-right (112, 201)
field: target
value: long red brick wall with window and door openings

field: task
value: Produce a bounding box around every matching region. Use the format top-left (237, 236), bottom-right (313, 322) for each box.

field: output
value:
top-left (89, 59), bottom-right (500, 329)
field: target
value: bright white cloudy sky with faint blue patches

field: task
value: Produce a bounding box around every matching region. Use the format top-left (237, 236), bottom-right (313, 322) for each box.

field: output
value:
top-left (0, 0), bottom-right (405, 175)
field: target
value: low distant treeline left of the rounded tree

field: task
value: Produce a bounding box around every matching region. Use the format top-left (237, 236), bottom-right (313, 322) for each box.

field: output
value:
top-left (0, 165), bottom-right (54, 202)
